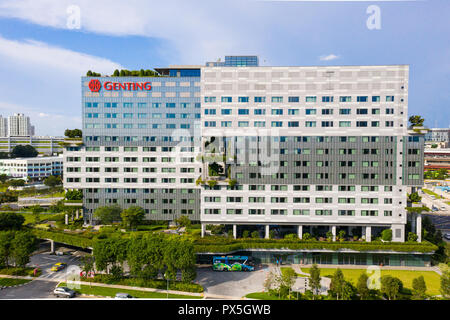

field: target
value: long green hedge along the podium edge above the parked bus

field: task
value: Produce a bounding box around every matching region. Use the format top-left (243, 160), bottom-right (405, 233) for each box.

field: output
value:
top-left (194, 237), bottom-right (437, 253)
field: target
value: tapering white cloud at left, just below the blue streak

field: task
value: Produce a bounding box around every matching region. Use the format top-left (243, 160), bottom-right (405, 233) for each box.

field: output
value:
top-left (0, 36), bottom-right (122, 75)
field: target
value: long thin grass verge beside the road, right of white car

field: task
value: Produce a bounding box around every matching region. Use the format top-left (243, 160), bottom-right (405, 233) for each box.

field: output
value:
top-left (58, 282), bottom-right (202, 299)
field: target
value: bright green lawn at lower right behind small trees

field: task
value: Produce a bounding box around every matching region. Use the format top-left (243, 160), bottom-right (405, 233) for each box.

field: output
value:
top-left (302, 268), bottom-right (441, 295)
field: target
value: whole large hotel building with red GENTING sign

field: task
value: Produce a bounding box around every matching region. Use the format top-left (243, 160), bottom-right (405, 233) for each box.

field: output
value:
top-left (64, 56), bottom-right (424, 248)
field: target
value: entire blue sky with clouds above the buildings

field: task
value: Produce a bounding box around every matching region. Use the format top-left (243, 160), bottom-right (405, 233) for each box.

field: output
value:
top-left (0, 0), bottom-right (450, 136)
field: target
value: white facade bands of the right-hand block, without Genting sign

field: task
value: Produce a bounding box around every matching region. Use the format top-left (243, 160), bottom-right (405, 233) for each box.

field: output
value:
top-left (201, 65), bottom-right (409, 241)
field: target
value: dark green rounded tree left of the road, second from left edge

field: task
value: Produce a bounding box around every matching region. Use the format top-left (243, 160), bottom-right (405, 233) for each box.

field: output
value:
top-left (11, 231), bottom-right (38, 268)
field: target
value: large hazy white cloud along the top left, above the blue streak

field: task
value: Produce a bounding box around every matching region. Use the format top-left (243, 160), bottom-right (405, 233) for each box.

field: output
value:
top-left (0, 0), bottom-right (292, 64)
